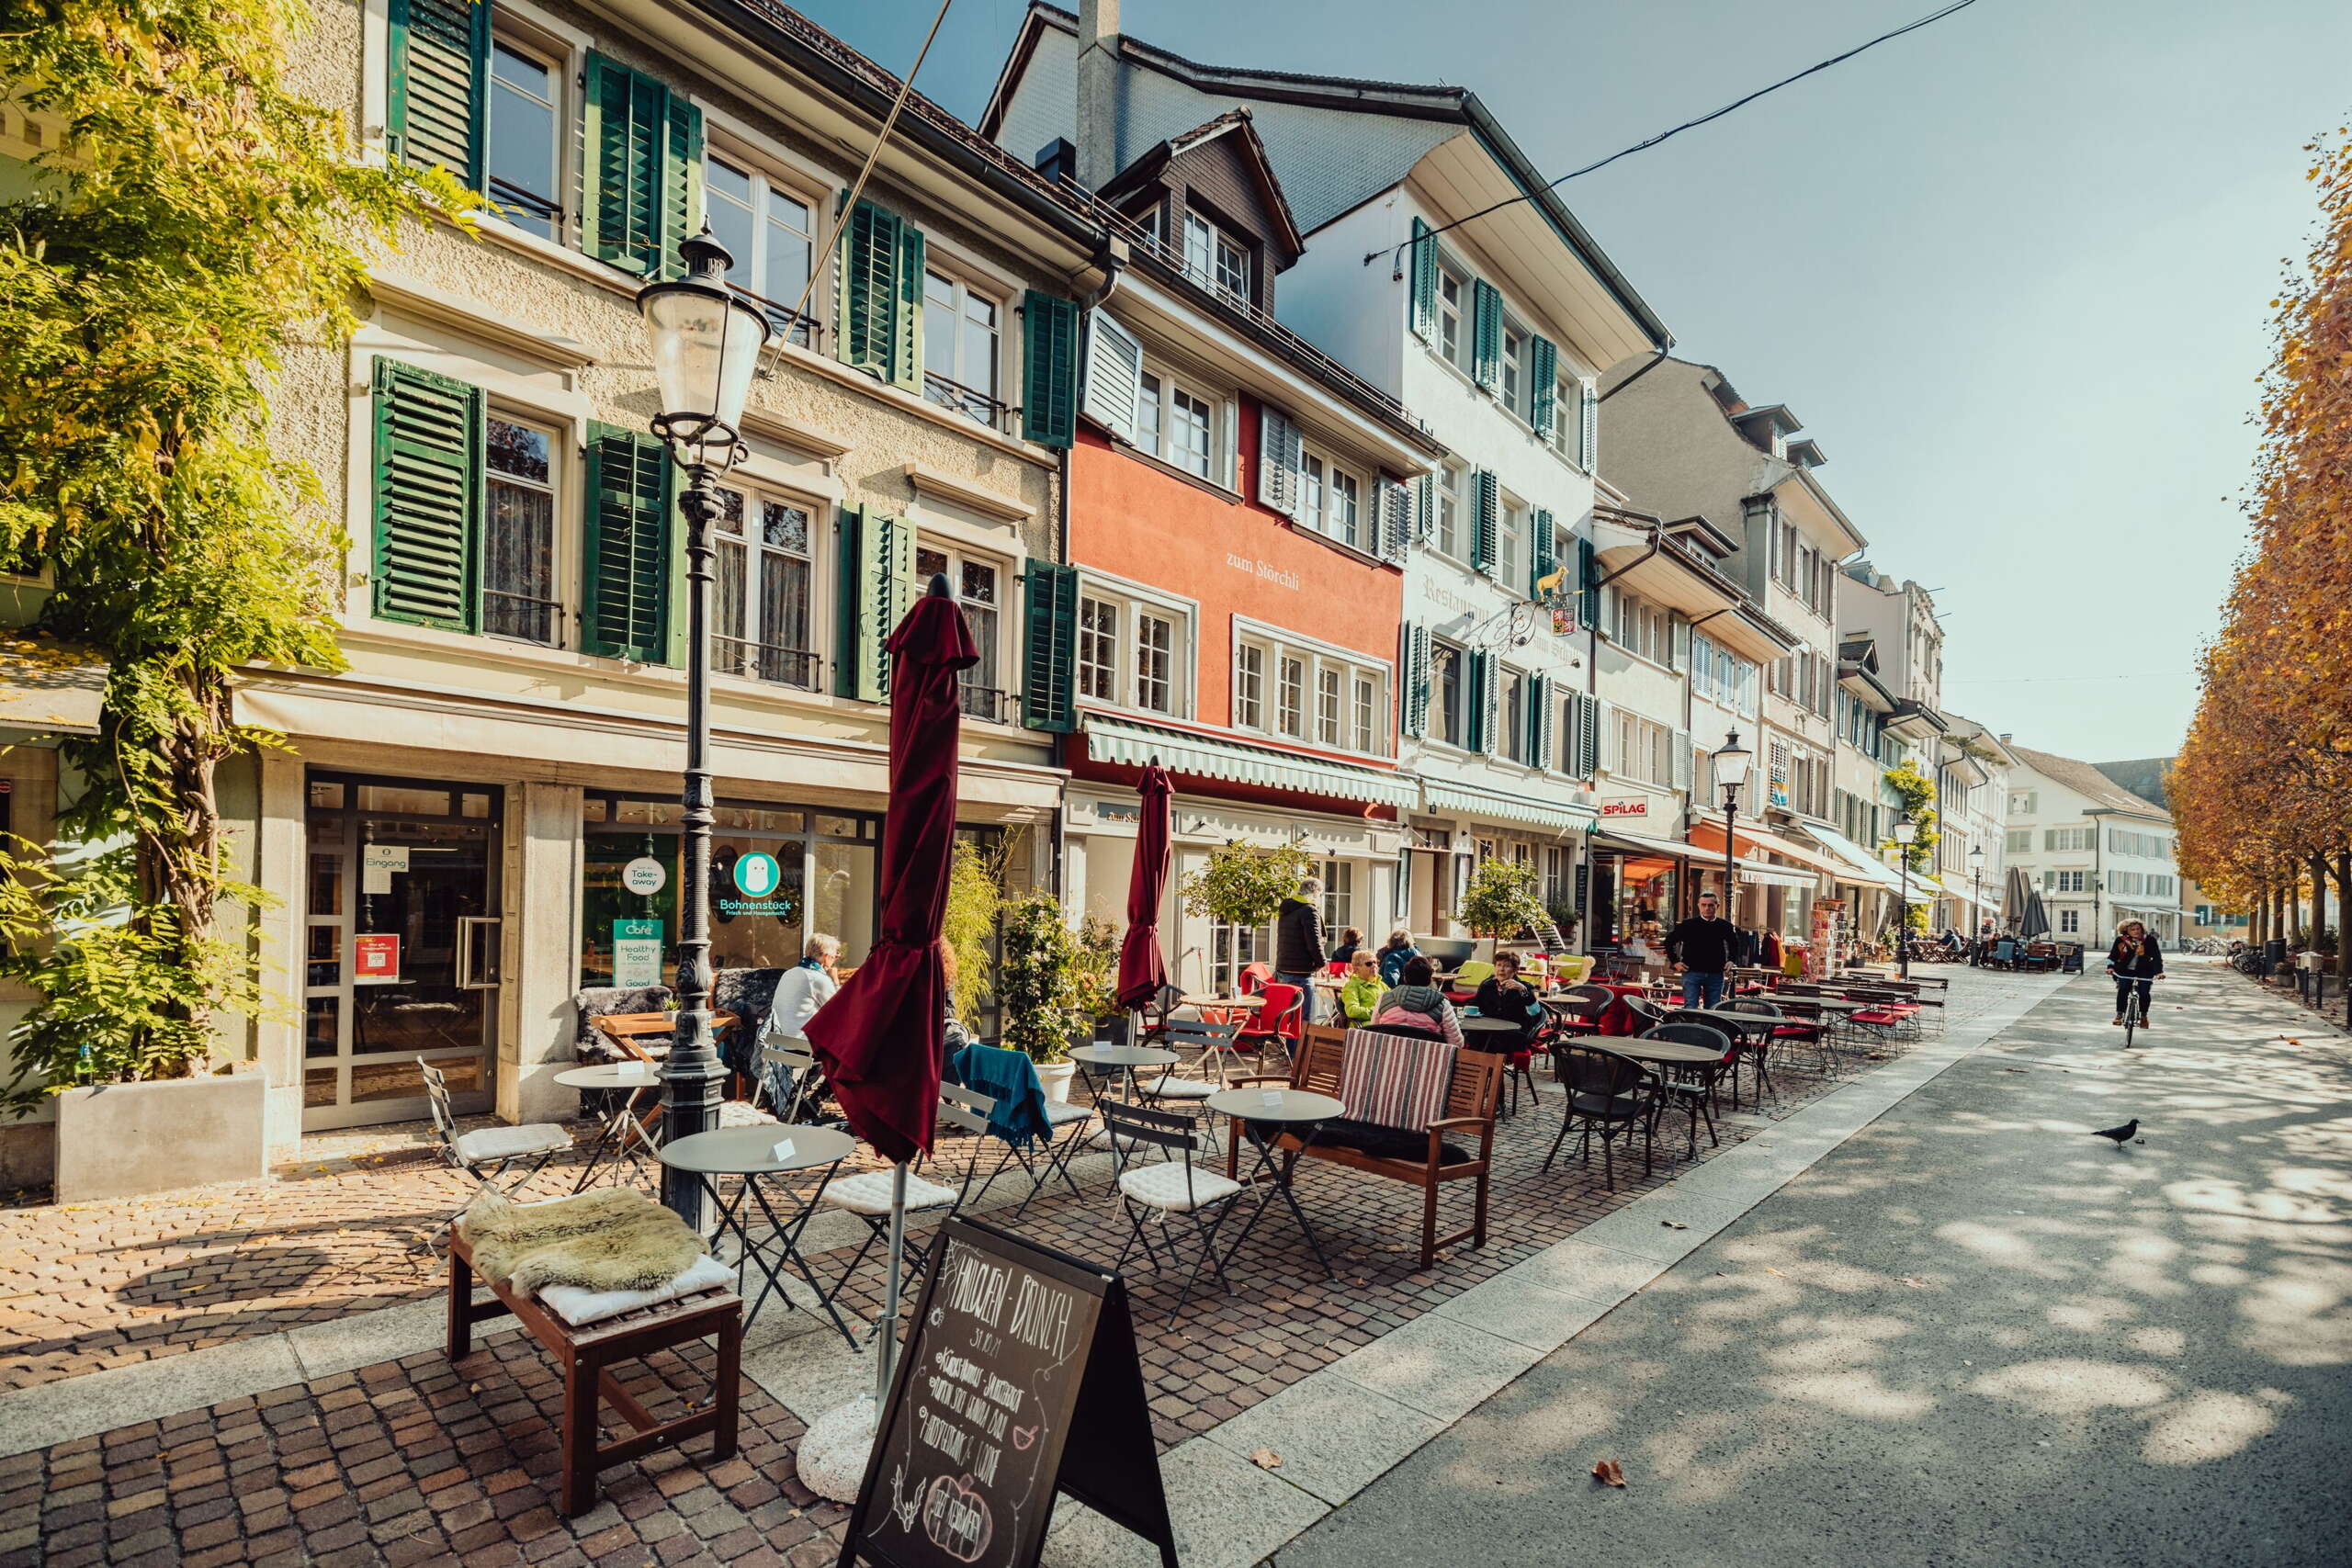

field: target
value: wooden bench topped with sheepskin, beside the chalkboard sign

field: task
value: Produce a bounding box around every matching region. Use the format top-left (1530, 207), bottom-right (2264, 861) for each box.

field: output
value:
top-left (449, 1187), bottom-right (743, 1517)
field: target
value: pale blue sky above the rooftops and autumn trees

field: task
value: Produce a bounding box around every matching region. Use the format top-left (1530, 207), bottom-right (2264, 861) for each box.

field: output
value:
top-left (802, 0), bottom-right (2352, 760)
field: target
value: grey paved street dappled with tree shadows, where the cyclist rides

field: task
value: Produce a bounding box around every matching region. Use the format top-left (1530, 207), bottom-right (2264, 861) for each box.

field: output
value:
top-left (1275, 962), bottom-right (2352, 1568)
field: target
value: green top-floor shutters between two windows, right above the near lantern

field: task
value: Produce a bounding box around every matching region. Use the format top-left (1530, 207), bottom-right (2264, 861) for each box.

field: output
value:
top-left (581, 54), bottom-right (703, 277)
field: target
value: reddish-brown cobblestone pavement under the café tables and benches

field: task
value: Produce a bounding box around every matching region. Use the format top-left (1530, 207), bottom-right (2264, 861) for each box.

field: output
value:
top-left (0, 974), bottom-right (2046, 1568)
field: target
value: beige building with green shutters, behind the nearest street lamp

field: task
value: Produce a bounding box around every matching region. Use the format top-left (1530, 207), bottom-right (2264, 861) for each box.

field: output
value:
top-left (240, 0), bottom-right (1128, 1147)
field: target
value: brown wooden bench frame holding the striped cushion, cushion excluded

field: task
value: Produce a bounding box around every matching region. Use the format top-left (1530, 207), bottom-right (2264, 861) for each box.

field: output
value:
top-left (1226, 1025), bottom-right (1503, 1269)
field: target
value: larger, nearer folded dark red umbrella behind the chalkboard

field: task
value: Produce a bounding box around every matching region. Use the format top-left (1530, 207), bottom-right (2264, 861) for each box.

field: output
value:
top-left (807, 576), bottom-right (981, 1164)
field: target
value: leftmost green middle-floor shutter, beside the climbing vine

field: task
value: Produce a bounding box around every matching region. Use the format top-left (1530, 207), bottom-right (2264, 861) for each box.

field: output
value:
top-left (369, 360), bottom-right (475, 632)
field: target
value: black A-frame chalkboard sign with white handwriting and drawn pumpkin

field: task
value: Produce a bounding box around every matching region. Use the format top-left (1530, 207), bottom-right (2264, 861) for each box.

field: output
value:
top-left (840, 1218), bottom-right (1176, 1568)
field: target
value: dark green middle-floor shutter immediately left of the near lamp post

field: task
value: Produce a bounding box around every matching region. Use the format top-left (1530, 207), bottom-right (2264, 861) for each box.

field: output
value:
top-left (581, 425), bottom-right (680, 665)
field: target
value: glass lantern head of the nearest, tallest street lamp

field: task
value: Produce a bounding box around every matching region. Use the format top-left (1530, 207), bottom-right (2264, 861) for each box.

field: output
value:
top-left (638, 231), bottom-right (769, 463)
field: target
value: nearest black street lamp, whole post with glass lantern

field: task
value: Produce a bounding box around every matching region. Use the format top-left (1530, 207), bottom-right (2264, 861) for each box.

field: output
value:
top-left (638, 231), bottom-right (769, 1229)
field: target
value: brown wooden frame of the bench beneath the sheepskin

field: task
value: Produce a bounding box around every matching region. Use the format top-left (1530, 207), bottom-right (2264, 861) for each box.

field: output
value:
top-left (449, 1227), bottom-right (743, 1517)
